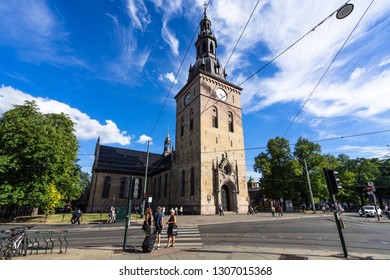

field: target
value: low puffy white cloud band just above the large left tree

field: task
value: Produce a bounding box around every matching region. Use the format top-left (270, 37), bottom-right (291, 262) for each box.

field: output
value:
top-left (0, 86), bottom-right (131, 145)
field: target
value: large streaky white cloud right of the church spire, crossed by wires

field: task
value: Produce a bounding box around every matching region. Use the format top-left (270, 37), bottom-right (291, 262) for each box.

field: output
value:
top-left (208, 0), bottom-right (390, 126)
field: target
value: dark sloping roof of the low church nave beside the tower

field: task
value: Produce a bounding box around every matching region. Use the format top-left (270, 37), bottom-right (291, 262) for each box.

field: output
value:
top-left (95, 145), bottom-right (171, 175)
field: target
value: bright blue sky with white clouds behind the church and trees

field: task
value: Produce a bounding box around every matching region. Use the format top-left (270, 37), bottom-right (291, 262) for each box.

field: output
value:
top-left (0, 0), bottom-right (390, 179)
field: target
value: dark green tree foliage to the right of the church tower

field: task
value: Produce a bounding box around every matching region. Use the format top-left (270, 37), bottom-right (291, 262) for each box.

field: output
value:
top-left (254, 137), bottom-right (390, 208)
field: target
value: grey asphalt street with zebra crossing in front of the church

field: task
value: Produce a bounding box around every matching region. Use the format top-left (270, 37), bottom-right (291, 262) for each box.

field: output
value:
top-left (11, 213), bottom-right (390, 257)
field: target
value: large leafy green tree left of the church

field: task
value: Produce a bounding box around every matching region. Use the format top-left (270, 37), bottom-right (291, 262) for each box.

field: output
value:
top-left (0, 101), bottom-right (81, 219)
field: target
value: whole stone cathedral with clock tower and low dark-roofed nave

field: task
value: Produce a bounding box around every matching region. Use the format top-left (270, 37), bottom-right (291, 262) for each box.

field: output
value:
top-left (86, 10), bottom-right (249, 215)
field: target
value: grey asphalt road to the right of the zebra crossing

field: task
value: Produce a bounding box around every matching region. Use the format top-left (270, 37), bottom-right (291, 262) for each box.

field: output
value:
top-left (200, 215), bottom-right (390, 255)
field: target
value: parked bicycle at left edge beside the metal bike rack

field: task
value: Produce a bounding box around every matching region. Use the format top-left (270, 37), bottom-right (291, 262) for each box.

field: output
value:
top-left (0, 226), bottom-right (32, 260)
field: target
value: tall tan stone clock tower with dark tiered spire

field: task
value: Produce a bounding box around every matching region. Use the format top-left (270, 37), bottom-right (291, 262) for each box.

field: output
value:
top-left (171, 9), bottom-right (248, 214)
